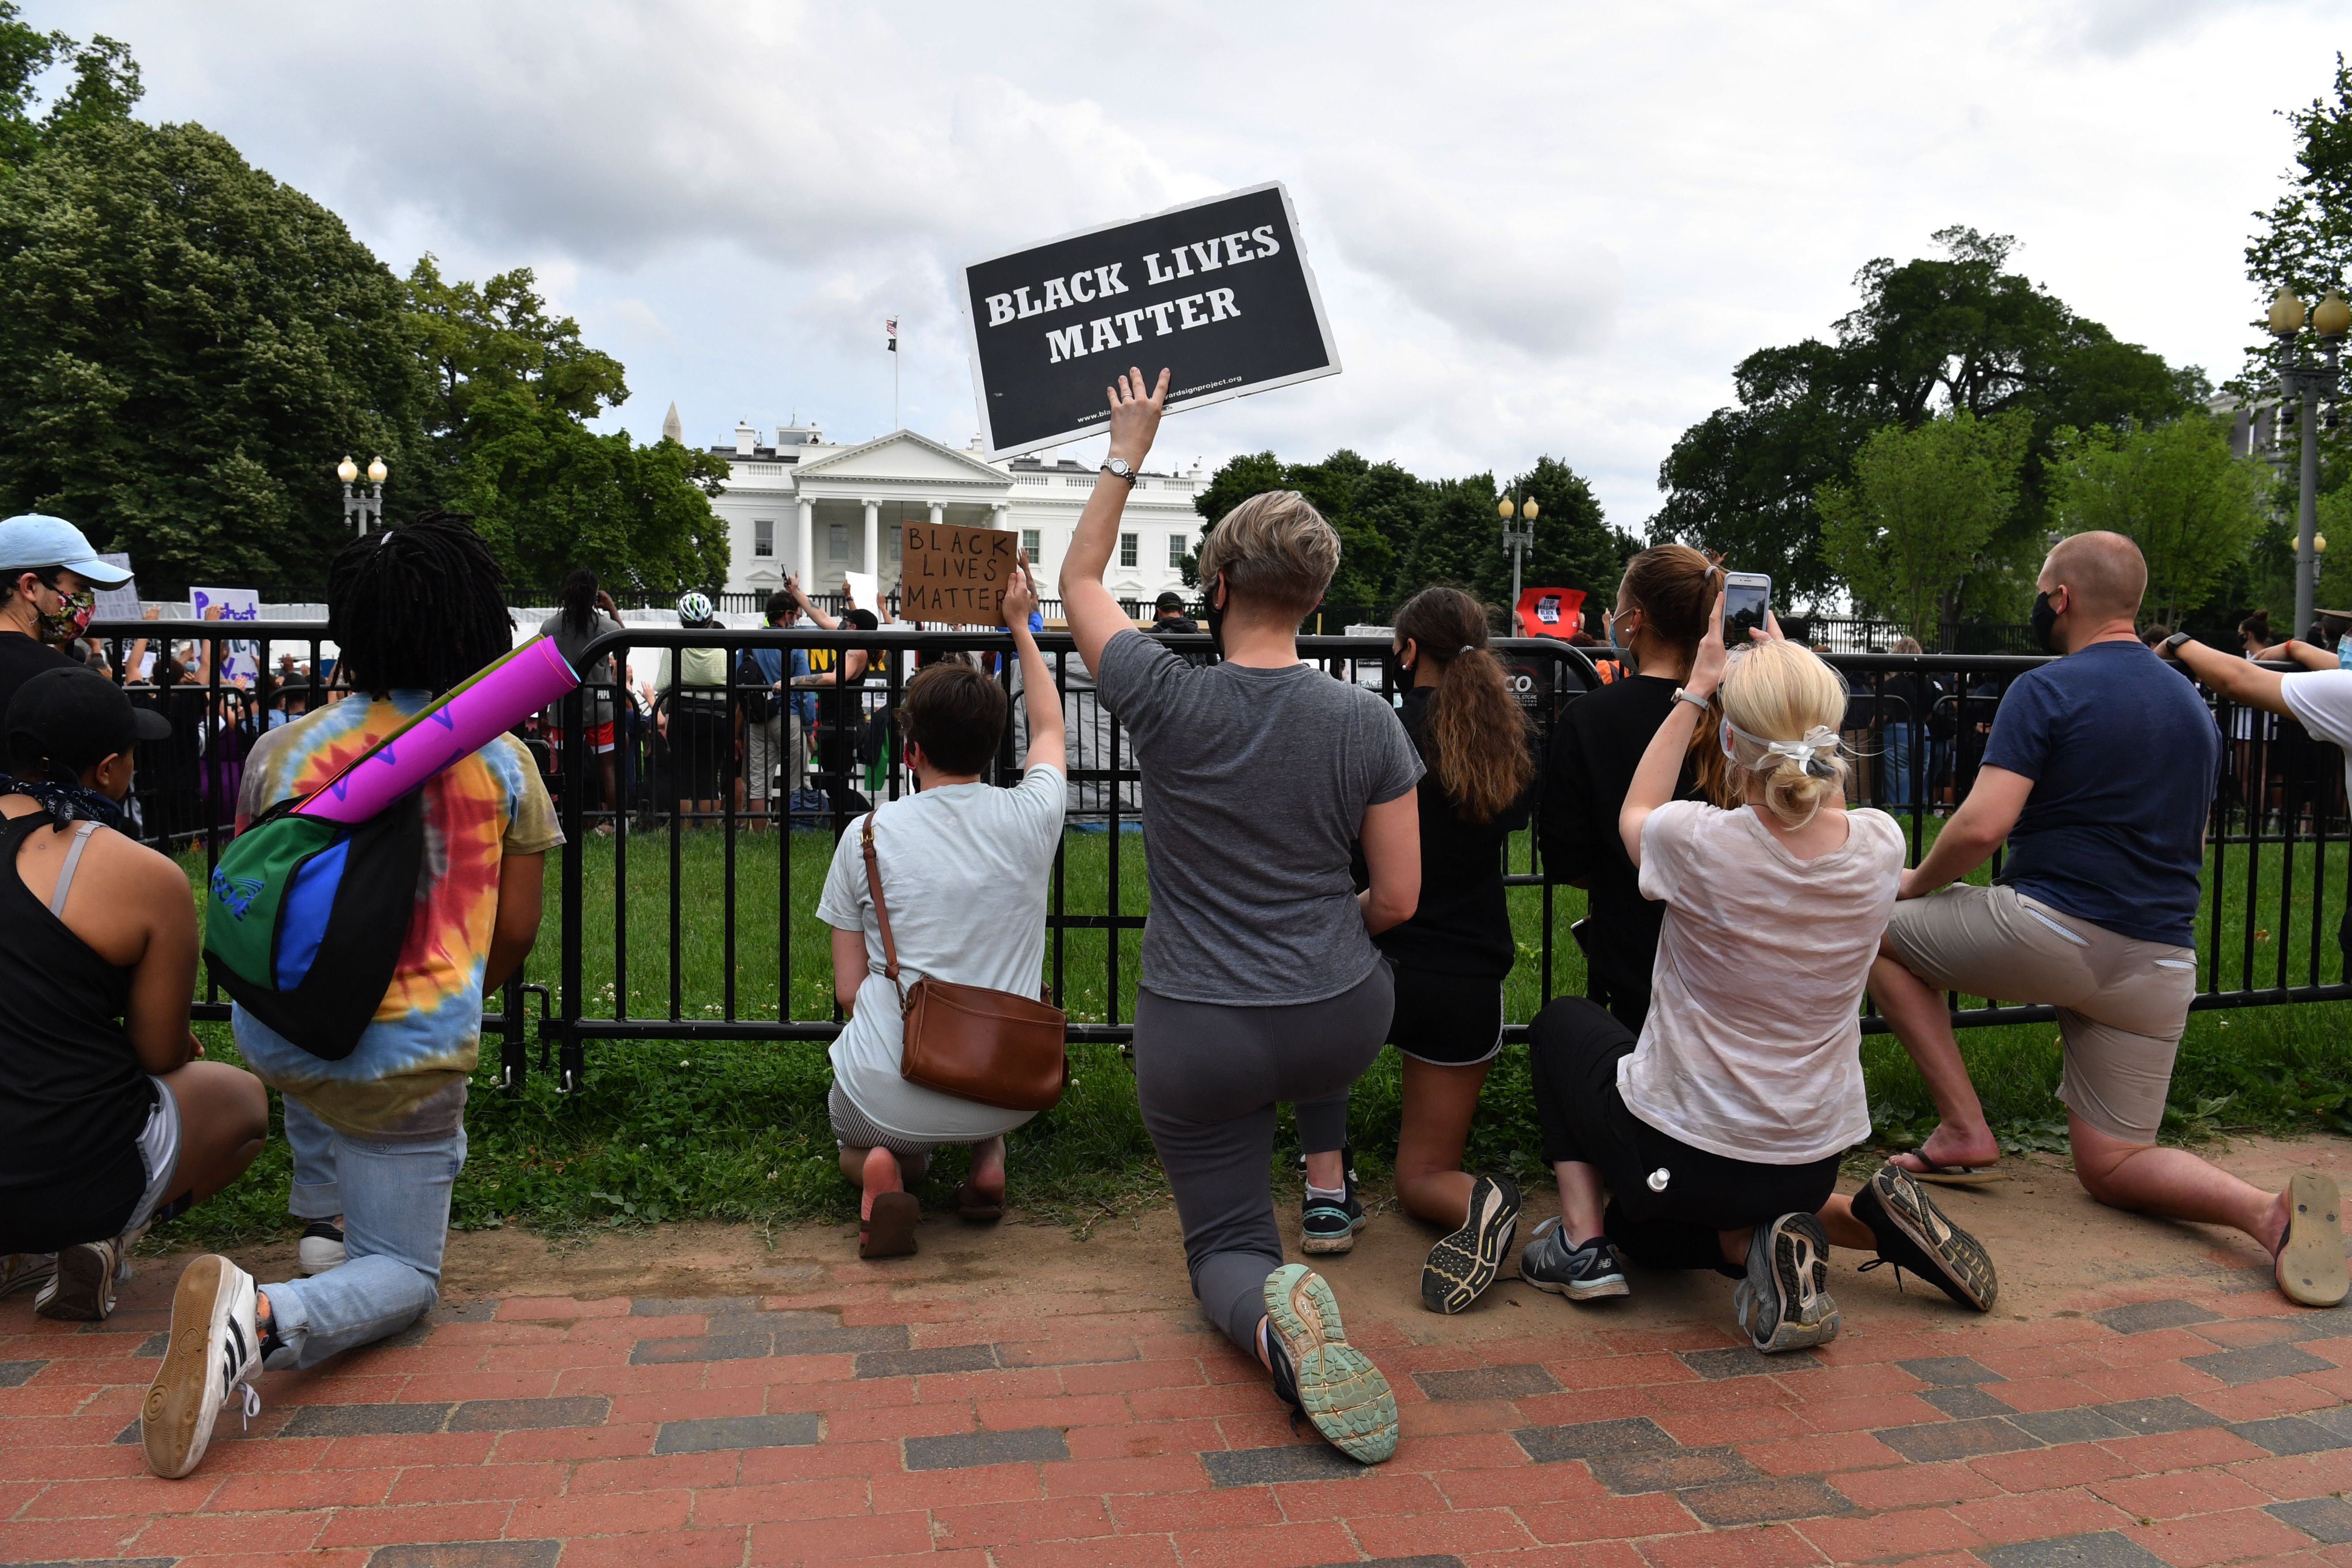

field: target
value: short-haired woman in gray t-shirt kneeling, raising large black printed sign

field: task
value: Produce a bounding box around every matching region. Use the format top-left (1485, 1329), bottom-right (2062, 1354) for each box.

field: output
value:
top-left (1061, 372), bottom-right (1420, 1464)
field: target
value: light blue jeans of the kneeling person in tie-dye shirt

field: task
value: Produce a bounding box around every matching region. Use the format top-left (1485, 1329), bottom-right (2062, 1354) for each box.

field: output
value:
top-left (261, 1096), bottom-right (466, 1371)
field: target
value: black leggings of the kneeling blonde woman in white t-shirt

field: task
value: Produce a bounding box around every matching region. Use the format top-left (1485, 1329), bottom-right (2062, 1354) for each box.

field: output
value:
top-left (1527, 997), bottom-right (1839, 1277)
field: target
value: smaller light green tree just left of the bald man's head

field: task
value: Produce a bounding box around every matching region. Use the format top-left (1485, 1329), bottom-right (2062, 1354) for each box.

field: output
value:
top-left (1813, 409), bottom-right (2032, 647)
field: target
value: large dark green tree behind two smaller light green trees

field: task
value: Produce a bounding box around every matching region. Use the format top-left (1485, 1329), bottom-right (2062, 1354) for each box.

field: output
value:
top-left (1651, 228), bottom-right (2202, 611)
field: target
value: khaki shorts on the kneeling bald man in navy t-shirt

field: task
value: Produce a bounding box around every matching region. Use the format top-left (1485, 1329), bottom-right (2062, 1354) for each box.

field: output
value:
top-left (1886, 886), bottom-right (2197, 1142)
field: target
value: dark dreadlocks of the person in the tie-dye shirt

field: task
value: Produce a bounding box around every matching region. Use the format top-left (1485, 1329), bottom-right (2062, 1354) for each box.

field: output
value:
top-left (327, 513), bottom-right (515, 691)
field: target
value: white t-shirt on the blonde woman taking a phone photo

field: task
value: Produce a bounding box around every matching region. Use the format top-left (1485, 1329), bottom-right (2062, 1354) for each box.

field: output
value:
top-left (1618, 799), bottom-right (1903, 1166)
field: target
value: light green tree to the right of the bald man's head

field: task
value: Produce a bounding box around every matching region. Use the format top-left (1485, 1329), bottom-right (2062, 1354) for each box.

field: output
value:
top-left (2049, 414), bottom-right (2270, 625)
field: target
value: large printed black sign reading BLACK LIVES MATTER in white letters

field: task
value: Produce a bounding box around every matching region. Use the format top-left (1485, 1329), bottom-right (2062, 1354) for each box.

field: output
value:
top-left (962, 184), bottom-right (1338, 458)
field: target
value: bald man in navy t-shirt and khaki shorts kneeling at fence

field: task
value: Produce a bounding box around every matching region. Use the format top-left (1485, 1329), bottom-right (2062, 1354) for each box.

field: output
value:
top-left (1870, 533), bottom-right (2345, 1307)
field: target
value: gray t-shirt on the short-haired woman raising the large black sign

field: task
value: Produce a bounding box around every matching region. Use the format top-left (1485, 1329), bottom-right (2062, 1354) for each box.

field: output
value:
top-left (1096, 633), bottom-right (1420, 1006)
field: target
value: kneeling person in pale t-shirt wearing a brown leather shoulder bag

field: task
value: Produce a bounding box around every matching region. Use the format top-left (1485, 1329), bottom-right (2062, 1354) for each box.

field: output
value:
top-left (816, 569), bottom-right (1068, 1257)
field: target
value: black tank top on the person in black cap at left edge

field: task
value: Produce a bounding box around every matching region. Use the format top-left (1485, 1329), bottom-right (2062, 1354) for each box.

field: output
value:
top-left (0, 811), bottom-right (155, 1253)
